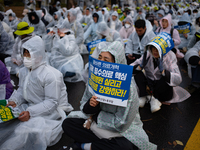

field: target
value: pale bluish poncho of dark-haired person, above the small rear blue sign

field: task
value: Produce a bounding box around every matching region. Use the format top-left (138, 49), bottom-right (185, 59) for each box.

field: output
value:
top-left (84, 11), bottom-right (103, 43)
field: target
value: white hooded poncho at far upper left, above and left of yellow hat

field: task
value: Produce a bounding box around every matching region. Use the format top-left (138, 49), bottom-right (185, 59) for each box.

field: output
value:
top-left (4, 9), bottom-right (19, 30)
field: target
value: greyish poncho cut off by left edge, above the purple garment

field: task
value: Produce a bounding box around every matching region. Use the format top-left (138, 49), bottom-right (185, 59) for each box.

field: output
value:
top-left (0, 22), bottom-right (14, 55)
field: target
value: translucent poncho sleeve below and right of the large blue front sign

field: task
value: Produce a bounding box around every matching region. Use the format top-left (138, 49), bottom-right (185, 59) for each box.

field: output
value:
top-left (97, 79), bottom-right (139, 132)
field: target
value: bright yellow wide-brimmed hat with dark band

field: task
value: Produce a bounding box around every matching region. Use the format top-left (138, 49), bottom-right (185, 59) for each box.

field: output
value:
top-left (14, 22), bottom-right (34, 35)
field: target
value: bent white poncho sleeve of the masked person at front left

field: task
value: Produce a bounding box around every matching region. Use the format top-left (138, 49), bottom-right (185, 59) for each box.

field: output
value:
top-left (27, 72), bottom-right (62, 117)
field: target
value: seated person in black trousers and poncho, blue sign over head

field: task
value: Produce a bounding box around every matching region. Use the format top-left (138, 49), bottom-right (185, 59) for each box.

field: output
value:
top-left (131, 39), bottom-right (190, 113)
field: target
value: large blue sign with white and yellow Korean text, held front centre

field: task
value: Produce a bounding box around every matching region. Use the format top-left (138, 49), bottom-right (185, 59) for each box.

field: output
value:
top-left (88, 56), bottom-right (133, 107)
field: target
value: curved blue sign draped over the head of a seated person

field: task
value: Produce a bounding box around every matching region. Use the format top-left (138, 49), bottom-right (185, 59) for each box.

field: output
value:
top-left (150, 32), bottom-right (174, 56)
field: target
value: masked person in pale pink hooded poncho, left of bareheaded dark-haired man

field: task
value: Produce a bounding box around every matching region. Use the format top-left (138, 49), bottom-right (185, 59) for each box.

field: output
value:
top-left (119, 16), bottom-right (135, 39)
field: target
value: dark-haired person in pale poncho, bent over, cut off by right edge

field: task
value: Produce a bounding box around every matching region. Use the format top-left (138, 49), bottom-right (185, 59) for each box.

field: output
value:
top-left (184, 41), bottom-right (200, 93)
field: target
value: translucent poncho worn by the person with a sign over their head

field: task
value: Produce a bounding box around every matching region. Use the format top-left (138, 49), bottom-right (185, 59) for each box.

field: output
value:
top-left (130, 42), bottom-right (190, 103)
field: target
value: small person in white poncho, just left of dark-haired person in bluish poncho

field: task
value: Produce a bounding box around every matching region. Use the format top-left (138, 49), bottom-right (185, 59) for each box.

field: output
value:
top-left (80, 7), bottom-right (93, 32)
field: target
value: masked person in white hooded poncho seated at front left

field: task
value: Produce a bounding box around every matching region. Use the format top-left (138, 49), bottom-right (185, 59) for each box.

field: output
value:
top-left (0, 36), bottom-right (73, 150)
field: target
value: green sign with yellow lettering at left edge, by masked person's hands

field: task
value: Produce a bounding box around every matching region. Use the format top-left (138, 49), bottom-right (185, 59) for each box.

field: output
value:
top-left (0, 100), bottom-right (15, 123)
